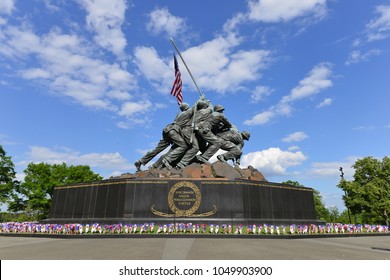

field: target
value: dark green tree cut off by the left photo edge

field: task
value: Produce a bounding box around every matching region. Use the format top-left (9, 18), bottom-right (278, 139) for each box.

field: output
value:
top-left (0, 145), bottom-right (17, 203)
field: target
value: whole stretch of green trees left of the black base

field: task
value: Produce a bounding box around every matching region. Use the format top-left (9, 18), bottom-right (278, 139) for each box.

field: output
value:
top-left (0, 145), bottom-right (103, 221)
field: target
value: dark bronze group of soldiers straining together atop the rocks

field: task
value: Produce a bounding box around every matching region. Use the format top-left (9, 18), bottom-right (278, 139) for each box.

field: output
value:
top-left (134, 96), bottom-right (250, 171)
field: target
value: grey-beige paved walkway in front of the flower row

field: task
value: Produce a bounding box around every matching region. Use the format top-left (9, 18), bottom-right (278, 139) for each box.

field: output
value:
top-left (0, 236), bottom-right (390, 260)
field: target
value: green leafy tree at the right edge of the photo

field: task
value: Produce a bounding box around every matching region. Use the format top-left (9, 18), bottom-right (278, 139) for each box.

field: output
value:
top-left (339, 157), bottom-right (390, 225)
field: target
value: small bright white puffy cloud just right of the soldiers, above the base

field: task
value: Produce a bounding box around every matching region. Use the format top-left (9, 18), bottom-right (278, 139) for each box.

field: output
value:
top-left (241, 148), bottom-right (306, 177)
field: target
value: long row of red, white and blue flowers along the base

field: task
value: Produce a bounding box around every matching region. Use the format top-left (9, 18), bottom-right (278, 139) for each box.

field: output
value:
top-left (0, 222), bottom-right (389, 235)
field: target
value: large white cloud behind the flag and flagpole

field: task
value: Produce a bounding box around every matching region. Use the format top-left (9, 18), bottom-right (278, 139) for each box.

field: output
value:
top-left (134, 34), bottom-right (271, 93)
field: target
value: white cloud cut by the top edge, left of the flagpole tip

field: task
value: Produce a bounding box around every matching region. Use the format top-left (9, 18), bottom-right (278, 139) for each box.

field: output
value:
top-left (78, 0), bottom-right (127, 56)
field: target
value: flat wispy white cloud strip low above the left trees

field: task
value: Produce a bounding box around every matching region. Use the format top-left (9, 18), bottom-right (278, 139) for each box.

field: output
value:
top-left (23, 146), bottom-right (133, 172)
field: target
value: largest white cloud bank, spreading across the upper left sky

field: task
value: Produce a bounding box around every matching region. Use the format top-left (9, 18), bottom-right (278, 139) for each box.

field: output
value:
top-left (0, 26), bottom-right (136, 111)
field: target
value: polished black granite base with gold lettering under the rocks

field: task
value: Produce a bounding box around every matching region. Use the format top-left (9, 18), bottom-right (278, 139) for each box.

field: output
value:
top-left (46, 178), bottom-right (320, 225)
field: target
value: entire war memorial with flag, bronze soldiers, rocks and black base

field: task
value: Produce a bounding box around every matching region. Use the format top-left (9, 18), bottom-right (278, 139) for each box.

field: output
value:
top-left (46, 39), bottom-right (320, 225)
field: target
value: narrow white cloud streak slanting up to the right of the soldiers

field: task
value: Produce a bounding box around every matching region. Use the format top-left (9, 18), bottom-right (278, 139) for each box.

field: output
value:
top-left (244, 62), bottom-right (333, 126)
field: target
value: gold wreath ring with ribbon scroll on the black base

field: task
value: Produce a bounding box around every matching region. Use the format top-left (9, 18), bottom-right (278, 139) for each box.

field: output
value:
top-left (151, 181), bottom-right (217, 217)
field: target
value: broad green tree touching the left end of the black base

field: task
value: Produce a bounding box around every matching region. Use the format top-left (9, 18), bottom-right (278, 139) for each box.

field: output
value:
top-left (18, 162), bottom-right (103, 219)
